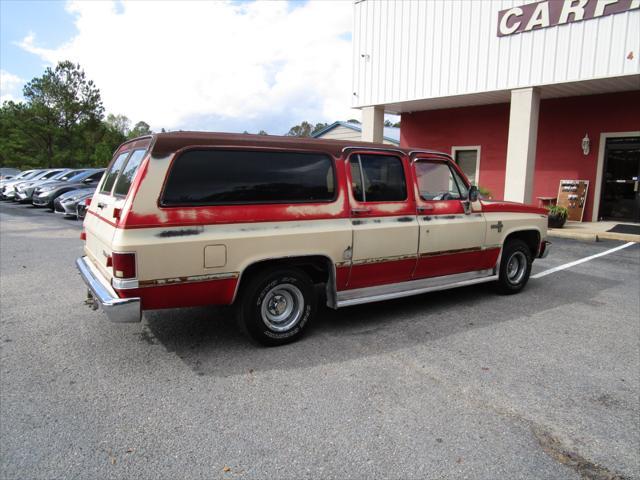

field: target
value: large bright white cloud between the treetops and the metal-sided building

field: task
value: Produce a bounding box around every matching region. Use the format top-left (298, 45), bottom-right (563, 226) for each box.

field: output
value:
top-left (20, 1), bottom-right (359, 133)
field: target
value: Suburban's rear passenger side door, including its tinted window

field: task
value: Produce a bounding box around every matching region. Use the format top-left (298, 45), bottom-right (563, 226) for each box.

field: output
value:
top-left (347, 150), bottom-right (418, 289)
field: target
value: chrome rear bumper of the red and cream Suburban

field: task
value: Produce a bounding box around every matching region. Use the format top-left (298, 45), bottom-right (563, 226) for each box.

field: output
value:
top-left (76, 257), bottom-right (141, 323)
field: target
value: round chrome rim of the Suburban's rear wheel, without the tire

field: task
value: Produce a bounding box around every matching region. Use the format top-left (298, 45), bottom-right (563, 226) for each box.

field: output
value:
top-left (260, 283), bottom-right (304, 332)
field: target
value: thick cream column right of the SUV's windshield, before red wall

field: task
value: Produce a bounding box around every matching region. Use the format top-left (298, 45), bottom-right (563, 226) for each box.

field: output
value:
top-left (504, 88), bottom-right (540, 203)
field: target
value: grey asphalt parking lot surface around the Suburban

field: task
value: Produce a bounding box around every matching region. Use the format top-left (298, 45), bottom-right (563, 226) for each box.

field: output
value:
top-left (0, 203), bottom-right (640, 479)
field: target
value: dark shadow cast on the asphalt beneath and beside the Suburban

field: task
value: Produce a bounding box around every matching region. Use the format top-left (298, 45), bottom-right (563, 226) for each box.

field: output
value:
top-left (140, 272), bottom-right (620, 377)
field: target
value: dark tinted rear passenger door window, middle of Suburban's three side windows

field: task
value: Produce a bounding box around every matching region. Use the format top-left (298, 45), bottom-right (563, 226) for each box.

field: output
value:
top-left (349, 154), bottom-right (407, 202)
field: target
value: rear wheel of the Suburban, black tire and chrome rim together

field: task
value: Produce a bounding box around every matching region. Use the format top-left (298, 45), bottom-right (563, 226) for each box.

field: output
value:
top-left (236, 268), bottom-right (317, 346)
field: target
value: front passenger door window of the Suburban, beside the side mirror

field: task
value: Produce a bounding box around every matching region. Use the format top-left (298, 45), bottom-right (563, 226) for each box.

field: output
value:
top-left (415, 160), bottom-right (468, 200)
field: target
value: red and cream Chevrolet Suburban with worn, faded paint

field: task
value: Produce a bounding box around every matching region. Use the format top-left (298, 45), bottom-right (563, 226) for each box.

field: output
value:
top-left (76, 132), bottom-right (549, 345)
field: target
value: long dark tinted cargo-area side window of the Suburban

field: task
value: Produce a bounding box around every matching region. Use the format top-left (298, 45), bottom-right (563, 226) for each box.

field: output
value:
top-left (162, 150), bottom-right (335, 206)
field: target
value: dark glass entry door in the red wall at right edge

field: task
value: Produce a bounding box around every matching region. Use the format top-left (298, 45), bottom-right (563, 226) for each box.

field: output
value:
top-left (600, 137), bottom-right (640, 222)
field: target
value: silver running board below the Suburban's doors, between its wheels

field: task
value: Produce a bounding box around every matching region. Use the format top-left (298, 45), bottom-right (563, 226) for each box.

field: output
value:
top-left (336, 269), bottom-right (498, 308)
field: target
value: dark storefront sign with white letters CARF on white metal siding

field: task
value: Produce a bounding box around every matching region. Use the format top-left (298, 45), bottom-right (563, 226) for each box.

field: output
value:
top-left (498, 0), bottom-right (640, 37)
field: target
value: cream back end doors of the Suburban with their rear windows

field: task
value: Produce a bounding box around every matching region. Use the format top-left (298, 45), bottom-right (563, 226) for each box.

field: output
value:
top-left (84, 141), bottom-right (149, 279)
